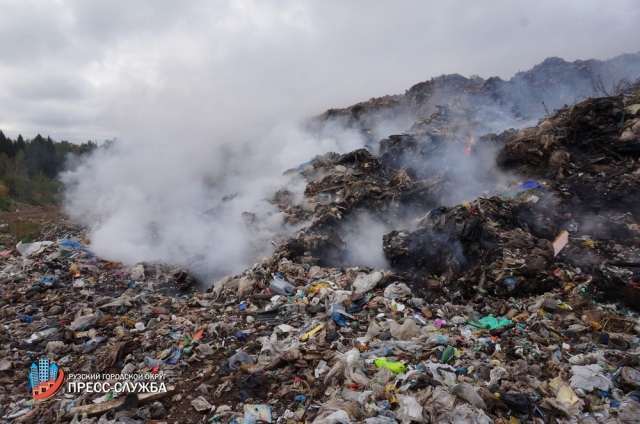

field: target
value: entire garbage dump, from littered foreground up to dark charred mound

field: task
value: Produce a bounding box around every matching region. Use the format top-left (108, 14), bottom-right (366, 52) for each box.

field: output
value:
top-left (0, 60), bottom-right (640, 424)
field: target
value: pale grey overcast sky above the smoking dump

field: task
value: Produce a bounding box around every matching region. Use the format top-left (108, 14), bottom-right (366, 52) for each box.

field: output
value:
top-left (0, 0), bottom-right (640, 142)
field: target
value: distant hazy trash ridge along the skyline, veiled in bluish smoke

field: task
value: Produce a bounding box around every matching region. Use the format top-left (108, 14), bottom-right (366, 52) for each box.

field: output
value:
top-left (319, 53), bottom-right (640, 137)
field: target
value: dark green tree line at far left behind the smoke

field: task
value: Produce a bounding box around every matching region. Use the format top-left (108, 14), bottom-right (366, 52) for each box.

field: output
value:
top-left (0, 130), bottom-right (98, 210)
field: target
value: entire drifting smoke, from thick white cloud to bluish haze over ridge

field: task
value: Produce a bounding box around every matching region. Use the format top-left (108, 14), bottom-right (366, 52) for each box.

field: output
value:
top-left (61, 53), bottom-right (640, 276)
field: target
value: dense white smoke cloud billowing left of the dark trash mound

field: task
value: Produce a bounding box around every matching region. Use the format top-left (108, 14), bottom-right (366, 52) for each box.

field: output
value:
top-left (61, 123), bottom-right (364, 273)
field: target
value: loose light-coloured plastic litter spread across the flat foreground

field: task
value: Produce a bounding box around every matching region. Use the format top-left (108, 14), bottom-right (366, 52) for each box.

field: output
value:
top-left (0, 224), bottom-right (640, 423)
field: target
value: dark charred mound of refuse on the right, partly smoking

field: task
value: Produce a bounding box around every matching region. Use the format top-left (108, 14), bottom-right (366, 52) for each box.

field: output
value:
top-left (271, 86), bottom-right (640, 307)
